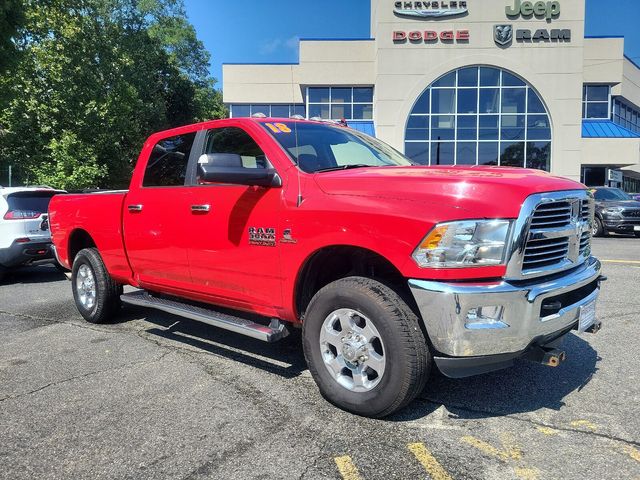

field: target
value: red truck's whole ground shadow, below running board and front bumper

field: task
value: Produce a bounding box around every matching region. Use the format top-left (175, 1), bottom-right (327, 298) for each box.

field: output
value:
top-left (135, 307), bottom-right (600, 422)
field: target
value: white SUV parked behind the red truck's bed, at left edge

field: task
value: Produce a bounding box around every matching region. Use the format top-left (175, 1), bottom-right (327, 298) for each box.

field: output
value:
top-left (0, 187), bottom-right (65, 279)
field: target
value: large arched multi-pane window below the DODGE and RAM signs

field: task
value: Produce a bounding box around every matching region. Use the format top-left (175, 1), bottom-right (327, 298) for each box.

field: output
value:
top-left (405, 66), bottom-right (551, 171)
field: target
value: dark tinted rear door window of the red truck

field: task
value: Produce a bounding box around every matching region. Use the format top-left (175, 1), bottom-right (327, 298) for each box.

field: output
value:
top-left (142, 132), bottom-right (196, 187)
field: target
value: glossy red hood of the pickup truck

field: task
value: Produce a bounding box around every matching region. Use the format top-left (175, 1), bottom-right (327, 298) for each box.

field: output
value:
top-left (314, 166), bottom-right (585, 218)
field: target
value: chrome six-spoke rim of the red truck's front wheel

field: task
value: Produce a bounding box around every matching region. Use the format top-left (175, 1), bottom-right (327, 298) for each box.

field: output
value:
top-left (320, 308), bottom-right (386, 392)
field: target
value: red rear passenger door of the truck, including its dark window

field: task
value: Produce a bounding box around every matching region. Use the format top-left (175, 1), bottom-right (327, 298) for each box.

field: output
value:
top-left (122, 132), bottom-right (196, 293)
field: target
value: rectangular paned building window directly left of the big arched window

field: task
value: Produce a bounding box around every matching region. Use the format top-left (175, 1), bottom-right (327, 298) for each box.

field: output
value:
top-left (307, 87), bottom-right (373, 120)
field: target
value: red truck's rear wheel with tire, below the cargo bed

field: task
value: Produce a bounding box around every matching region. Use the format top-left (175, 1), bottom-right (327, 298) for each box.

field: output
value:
top-left (71, 248), bottom-right (122, 323)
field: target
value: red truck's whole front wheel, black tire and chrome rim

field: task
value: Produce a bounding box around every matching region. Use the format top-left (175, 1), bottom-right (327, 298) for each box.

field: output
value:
top-left (302, 277), bottom-right (431, 418)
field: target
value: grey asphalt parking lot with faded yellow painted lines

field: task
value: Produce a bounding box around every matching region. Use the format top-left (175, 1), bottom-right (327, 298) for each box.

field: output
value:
top-left (0, 236), bottom-right (640, 480)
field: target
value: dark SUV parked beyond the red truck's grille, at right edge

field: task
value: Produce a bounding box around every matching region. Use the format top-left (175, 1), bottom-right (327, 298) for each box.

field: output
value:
top-left (592, 187), bottom-right (640, 237)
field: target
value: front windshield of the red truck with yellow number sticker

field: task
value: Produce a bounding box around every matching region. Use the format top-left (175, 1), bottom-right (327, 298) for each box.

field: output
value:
top-left (263, 122), bottom-right (413, 173)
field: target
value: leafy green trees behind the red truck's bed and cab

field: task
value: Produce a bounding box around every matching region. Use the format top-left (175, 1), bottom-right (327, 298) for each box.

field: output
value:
top-left (0, 0), bottom-right (225, 189)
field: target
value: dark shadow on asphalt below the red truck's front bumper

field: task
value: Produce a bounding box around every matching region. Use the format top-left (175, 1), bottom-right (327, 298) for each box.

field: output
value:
top-left (390, 333), bottom-right (601, 421)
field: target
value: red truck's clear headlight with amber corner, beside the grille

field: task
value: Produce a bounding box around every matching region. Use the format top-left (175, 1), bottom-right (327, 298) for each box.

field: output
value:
top-left (412, 220), bottom-right (511, 268)
